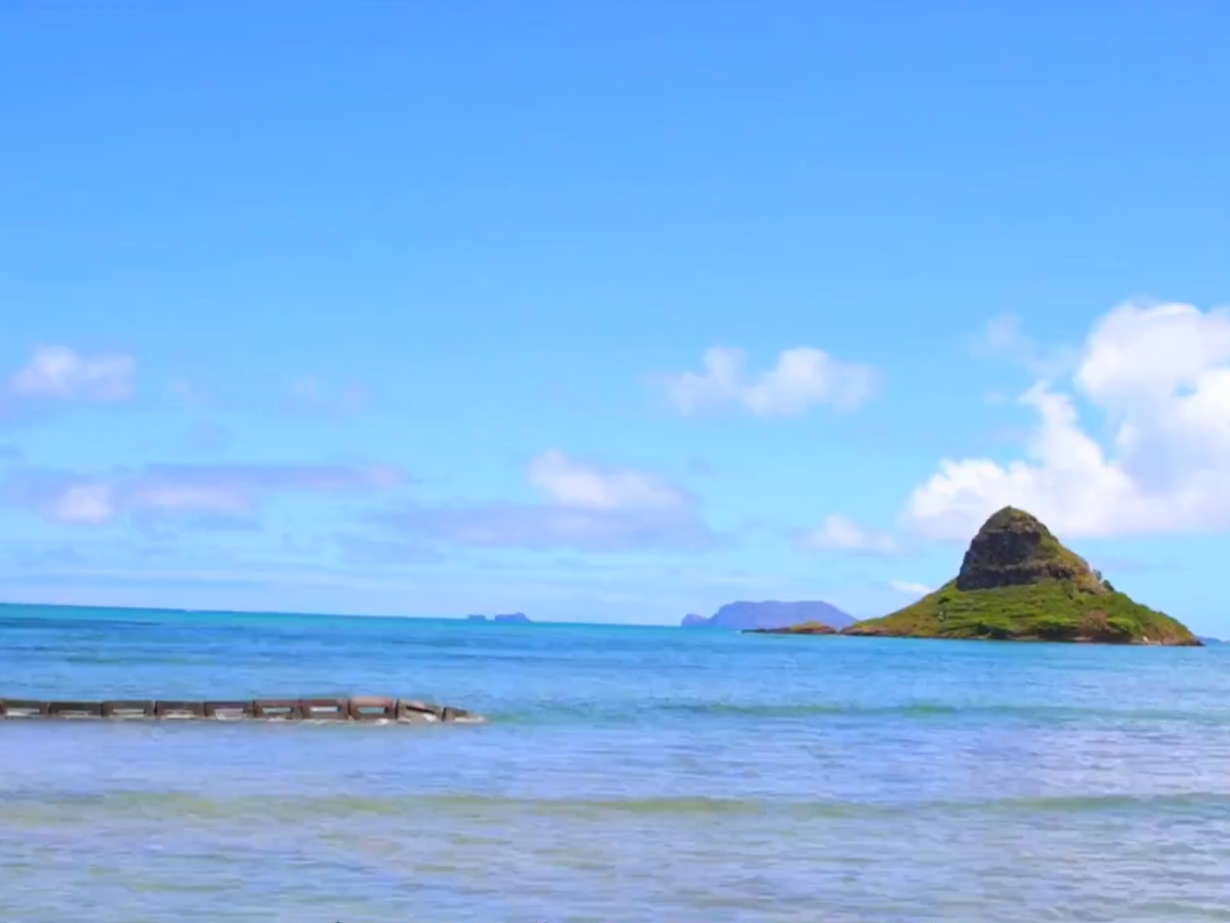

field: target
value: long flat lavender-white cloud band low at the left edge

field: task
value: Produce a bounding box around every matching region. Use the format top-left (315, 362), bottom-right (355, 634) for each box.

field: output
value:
top-left (0, 464), bottom-right (410, 525)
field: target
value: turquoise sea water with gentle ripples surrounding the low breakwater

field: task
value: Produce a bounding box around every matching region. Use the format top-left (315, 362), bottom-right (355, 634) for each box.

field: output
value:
top-left (0, 607), bottom-right (1230, 923)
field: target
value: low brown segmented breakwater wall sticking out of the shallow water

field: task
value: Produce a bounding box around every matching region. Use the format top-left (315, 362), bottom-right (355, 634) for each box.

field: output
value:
top-left (0, 695), bottom-right (485, 725)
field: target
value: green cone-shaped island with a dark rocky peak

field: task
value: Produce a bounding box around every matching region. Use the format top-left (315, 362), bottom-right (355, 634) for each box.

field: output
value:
top-left (841, 507), bottom-right (1200, 647)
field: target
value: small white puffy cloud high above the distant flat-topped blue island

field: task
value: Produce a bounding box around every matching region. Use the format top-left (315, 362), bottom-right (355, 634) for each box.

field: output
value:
top-left (662, 346), bottom-right (878, 417)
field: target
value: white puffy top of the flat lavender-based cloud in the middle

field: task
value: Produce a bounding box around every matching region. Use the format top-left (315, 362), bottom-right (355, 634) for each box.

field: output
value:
top-left (529, 449), bottom-right (686, 511)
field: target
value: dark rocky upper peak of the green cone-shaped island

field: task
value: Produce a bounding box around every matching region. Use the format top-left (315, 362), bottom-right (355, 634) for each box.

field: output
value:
top-left (957, 507), bottom-right (1108, 594)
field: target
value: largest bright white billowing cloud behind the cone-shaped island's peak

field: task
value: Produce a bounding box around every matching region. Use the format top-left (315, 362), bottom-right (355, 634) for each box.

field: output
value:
top-left (905, 304), bottom-right (1230, 539)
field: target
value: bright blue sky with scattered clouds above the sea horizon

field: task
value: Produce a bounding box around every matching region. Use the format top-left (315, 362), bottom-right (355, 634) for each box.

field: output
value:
top-left (0, 0), bottom-right (1230, 634)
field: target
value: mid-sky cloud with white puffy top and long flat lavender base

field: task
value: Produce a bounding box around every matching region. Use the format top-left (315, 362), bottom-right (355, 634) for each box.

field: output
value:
top-left (379, 449), bottom-right (717, 551)
